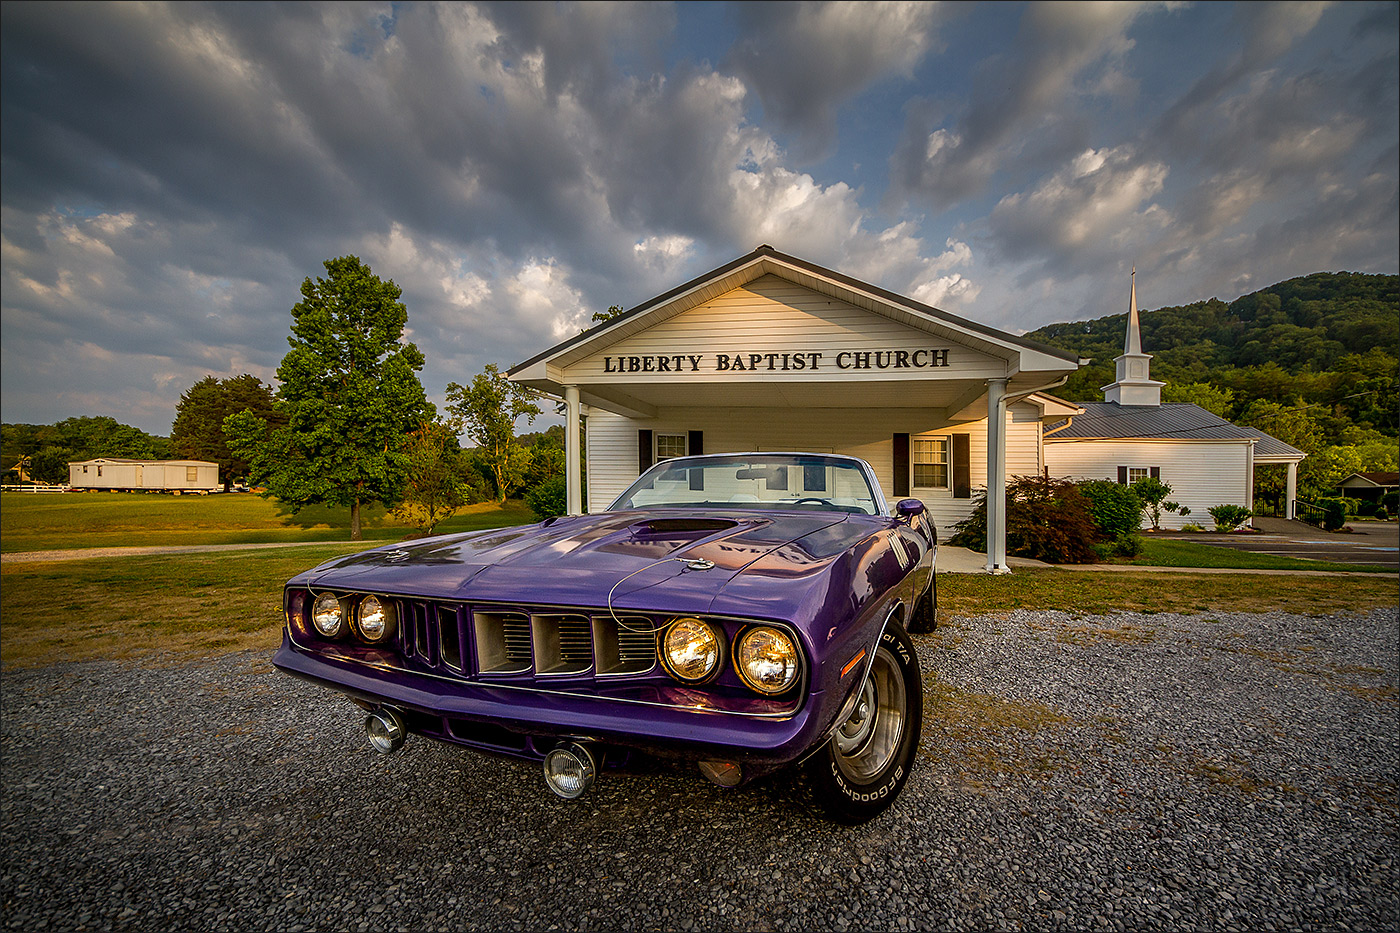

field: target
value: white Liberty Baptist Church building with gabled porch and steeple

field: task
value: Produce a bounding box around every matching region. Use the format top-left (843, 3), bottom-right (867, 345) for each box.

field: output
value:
top-left (508, 245), bottom-right (1301, 572)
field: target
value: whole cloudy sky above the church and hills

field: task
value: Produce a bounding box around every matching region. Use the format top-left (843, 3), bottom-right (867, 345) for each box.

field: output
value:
top-left (0, 1), bottom-right (1400, 434)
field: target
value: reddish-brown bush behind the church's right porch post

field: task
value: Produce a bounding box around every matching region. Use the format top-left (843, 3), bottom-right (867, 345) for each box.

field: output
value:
top-left (948, 476), bottom-right (1099, 563)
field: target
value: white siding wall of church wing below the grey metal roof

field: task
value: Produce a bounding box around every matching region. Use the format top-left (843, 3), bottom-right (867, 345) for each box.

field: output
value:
top-left (1044, 436), bottom-right (1253, 528)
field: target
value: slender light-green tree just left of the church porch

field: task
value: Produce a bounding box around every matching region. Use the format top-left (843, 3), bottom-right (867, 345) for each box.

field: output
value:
top-left (447, 363), bottom-right (540, 502)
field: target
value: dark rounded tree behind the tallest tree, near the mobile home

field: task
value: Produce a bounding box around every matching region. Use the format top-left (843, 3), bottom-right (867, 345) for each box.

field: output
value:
top-left (171, 373), bottom-right (283, 492)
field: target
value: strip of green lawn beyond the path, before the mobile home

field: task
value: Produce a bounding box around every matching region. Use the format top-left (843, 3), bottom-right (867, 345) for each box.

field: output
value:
top-left (0, 492), bottom-right (533, 553)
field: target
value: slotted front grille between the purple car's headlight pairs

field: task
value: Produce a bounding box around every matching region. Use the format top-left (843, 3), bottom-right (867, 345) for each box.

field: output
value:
top-left (398, 600), bottom-right (665, 678)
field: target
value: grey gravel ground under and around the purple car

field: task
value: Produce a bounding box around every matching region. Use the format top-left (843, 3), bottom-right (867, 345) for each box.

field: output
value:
top-left (0, 609), bottom-right (1400, 930)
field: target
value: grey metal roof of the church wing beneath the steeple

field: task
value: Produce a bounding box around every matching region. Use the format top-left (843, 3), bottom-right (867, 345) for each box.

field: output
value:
top-left (1046, 402), bottom-right (1306, 459)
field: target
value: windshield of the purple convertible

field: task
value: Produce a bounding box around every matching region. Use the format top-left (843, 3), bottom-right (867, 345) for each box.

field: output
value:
top-left (609, 454), bottom-right (881, 516)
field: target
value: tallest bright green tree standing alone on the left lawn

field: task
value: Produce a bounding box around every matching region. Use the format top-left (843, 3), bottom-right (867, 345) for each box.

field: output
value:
top-left (224, 256), bottom-right (435, 541)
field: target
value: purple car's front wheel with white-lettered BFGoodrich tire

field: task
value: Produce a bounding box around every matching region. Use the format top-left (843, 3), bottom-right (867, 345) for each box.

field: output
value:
top-left (798, 621), bottom-right (924, 824)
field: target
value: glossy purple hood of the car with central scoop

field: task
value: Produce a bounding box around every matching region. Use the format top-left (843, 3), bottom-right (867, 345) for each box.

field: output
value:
top-left (293, 510), bottom-right (889, 615)
